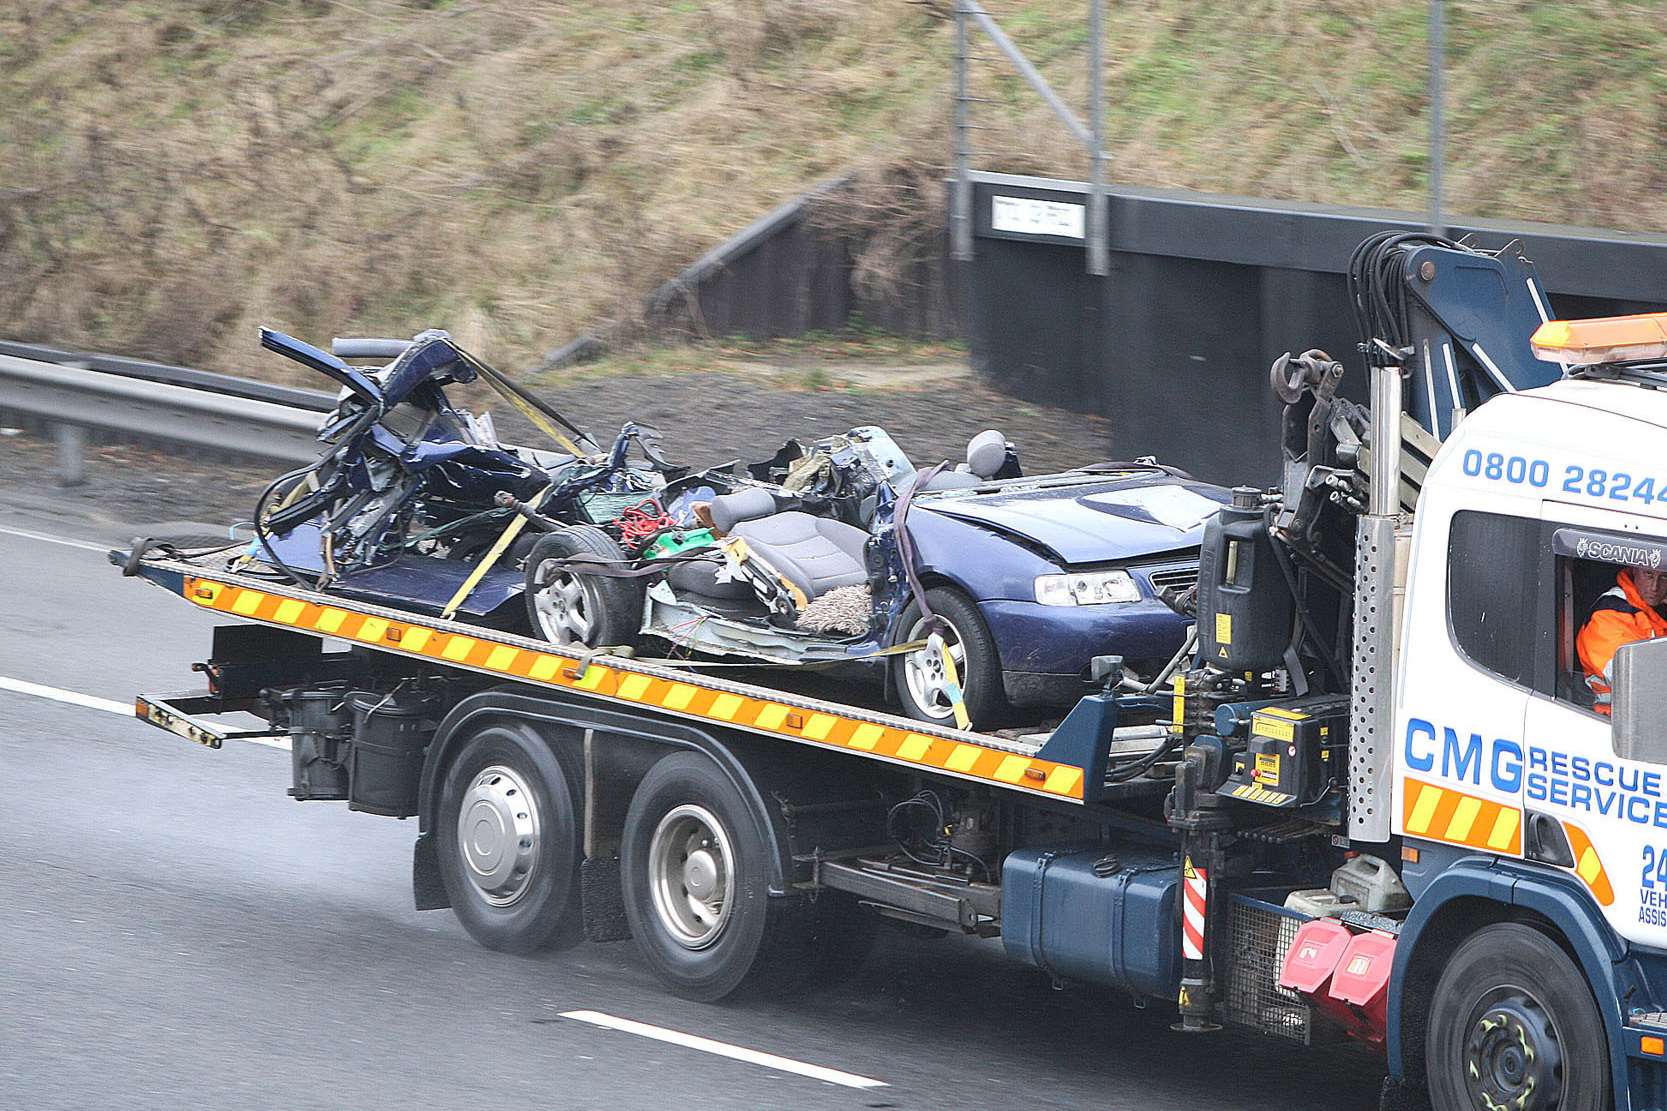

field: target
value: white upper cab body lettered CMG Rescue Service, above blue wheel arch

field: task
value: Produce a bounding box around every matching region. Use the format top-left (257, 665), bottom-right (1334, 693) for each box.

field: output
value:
top-left (1392, 333), bottom-right (1667, 948)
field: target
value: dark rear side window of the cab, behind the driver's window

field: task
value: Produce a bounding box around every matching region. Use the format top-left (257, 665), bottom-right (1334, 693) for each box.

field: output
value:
top-left (1447, 510), bottom-right (1550, 687)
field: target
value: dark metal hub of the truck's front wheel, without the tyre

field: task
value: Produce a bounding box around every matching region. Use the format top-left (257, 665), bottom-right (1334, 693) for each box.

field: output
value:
top-left (1464, 989), bottom-right (1564, 1111)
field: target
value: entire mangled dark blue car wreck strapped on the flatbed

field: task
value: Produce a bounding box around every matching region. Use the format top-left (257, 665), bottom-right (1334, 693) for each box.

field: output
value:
top-left (225, 330), bottom-right (1227, 729)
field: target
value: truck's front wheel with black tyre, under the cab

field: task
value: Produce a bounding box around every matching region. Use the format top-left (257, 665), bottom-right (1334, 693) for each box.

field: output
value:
top-left (1425, 922), bottom-right (1612, 1111)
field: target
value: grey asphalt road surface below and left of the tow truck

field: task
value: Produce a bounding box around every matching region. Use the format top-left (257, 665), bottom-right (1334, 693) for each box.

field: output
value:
top-left (0, 513), bottom-right (1382, 1111)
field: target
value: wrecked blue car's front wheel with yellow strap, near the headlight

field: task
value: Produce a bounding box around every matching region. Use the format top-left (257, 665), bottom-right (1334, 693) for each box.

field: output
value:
top-left (892, 587), bottom-right (1004, 729)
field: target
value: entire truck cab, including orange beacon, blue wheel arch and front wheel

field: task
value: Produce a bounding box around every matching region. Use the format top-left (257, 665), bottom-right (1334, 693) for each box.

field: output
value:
top-left (1389, 330), bottom-right (1667, 1108)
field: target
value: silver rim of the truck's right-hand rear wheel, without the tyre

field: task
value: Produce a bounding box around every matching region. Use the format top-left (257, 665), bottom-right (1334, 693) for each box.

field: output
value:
top-left (648, 804), bottom-right (735, 949)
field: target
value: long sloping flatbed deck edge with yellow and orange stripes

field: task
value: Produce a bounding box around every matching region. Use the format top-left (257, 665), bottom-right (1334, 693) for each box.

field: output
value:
top-left (120, 550), bottom-right (1085, 804)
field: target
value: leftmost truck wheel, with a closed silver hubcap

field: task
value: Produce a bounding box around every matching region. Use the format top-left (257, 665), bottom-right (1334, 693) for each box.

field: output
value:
top-left (435, 724), bottom-right (582, 953)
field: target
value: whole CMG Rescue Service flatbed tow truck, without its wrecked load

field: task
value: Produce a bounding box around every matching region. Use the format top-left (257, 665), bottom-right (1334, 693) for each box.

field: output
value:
top-left (112, 237), bottom-right (1667, 1111)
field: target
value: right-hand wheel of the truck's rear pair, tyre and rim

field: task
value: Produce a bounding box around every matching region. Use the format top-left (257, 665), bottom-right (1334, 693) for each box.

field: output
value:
top-left (620, 752), bottom-right (812, 1003)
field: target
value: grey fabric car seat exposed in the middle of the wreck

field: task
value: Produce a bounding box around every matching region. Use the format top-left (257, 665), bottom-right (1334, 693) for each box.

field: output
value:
top-left (712, 489), bottom-right (869, 601)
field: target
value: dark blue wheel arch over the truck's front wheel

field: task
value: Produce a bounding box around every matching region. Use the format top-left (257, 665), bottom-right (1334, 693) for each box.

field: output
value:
top-left (1385, 857), bottom-right (1627, 1108)
